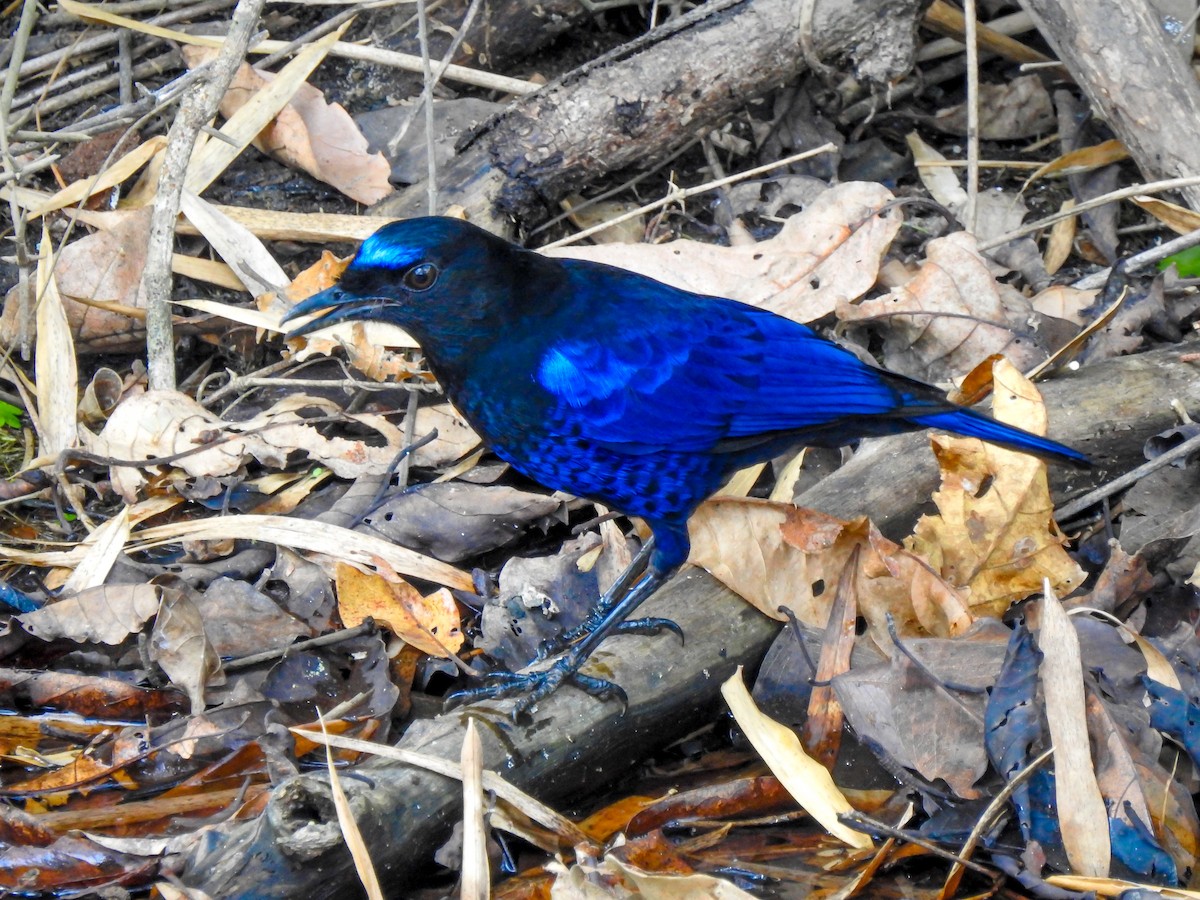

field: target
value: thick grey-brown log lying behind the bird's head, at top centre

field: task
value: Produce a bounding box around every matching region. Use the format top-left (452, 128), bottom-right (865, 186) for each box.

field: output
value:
top-left (373, 0), bottom-right (926, 233)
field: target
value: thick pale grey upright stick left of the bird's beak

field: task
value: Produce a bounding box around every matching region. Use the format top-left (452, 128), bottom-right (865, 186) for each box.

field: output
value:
top-left (142, 0), bottom-right (265, 390)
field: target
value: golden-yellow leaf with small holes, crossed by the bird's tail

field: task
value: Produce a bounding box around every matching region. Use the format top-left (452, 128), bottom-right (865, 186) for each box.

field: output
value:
top-left (905, 361), bottom-right (1084, 616)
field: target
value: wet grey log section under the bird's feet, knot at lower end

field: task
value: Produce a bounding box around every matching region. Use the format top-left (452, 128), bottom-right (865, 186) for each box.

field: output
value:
top-left (181, 569), bottom-right (779, 900)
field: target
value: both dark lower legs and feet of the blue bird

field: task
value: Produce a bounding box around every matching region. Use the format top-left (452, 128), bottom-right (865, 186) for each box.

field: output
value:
top-left (445, 546), bottom-right (683, 720)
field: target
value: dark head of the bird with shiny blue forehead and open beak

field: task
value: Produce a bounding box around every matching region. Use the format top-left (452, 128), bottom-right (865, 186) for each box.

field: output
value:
top-left (283, 216), bottom-right (533, 359)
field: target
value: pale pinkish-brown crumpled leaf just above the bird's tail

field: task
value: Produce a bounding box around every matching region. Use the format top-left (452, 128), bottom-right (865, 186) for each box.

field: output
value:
top-left (838, 232), bottom-right (1046, 380)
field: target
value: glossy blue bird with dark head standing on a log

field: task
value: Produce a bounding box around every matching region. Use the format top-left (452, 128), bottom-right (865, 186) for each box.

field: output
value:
top-left (286, 217), bottom-right (1088, 715)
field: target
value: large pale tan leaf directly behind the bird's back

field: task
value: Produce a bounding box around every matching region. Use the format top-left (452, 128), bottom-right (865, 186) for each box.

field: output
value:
top-left (547, 181), bottom-right (901, 322)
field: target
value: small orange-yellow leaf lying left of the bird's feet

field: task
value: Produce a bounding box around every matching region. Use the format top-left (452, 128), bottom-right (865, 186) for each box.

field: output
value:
top-left (337, 564), bottom-right (463, 659)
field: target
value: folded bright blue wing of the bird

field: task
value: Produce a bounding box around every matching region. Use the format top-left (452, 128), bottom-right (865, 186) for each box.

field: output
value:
top-left (535, 270), bottom-right (949, 452)
